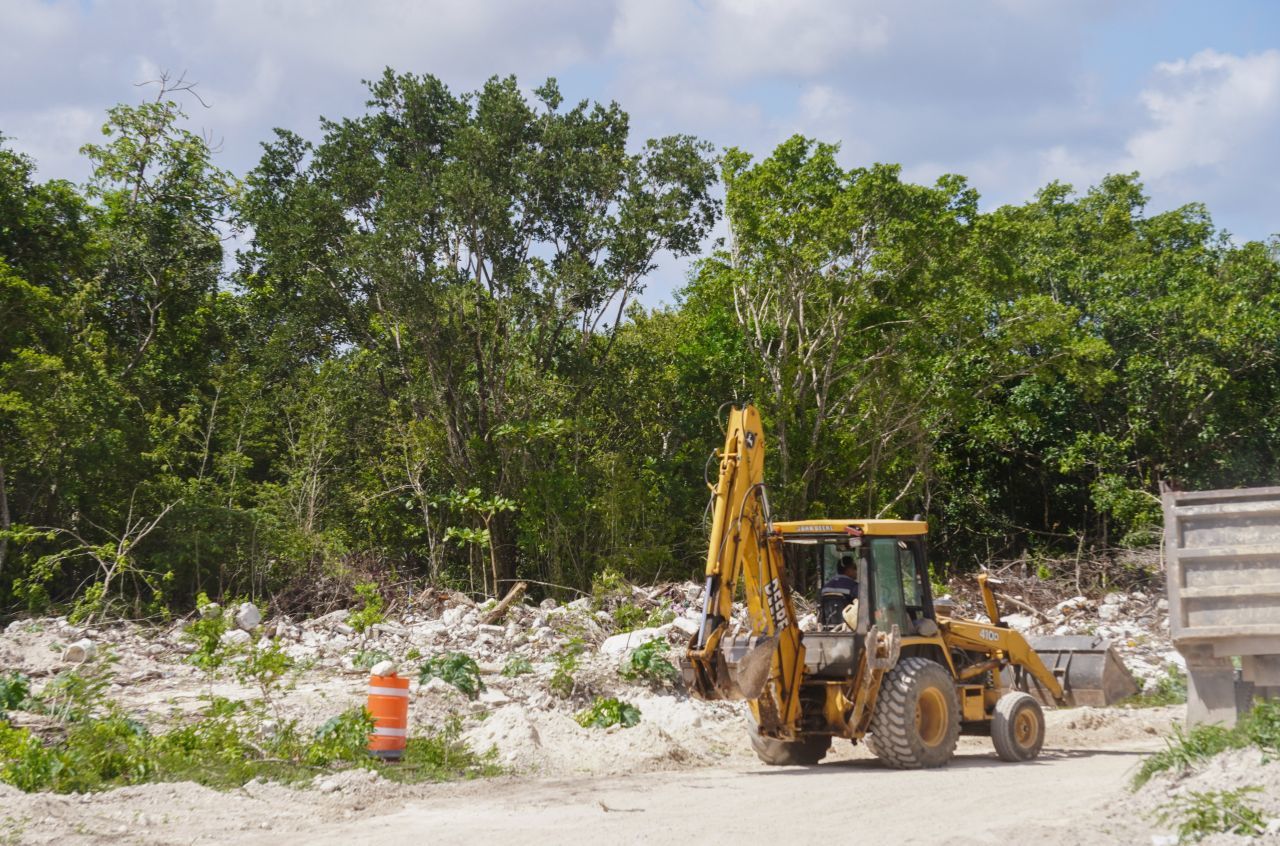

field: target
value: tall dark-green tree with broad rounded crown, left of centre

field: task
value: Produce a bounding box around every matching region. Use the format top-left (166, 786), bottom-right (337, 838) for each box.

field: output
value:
top-left (242, 70), bottom-right (716, 587)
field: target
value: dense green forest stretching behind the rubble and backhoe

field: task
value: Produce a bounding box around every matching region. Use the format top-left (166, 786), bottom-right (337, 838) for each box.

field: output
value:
top-left (0, 72), bottom-right (1280, 616)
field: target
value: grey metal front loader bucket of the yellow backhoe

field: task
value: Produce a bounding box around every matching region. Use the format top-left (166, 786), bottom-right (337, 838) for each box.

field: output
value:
top-left (1001, 635), bottom-right (1138, 708)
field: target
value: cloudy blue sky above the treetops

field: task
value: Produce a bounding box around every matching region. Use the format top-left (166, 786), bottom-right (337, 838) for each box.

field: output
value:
top-left (0, 0), bottom-right (1280, 303)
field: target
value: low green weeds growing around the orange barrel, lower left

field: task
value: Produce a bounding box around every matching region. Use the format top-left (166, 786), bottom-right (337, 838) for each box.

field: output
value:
top-left (0, 614), bottom-right (500, 794)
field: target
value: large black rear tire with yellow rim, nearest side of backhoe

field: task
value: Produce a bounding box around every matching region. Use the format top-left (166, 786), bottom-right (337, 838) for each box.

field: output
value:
top-left (867, 655), bottom-right (960, 769)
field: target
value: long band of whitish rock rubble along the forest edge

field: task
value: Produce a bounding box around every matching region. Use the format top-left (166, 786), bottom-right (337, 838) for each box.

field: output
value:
top-left (0, 570), bottom-right (1183, 742)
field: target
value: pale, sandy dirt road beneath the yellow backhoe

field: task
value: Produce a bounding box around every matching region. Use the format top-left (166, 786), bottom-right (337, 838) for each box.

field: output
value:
top-left (285, 738), bottom-right (1161, 846)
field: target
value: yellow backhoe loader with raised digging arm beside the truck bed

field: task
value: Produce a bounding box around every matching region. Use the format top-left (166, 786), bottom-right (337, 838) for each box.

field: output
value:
top-left (681, 406), bottom-right (1137, 769)
